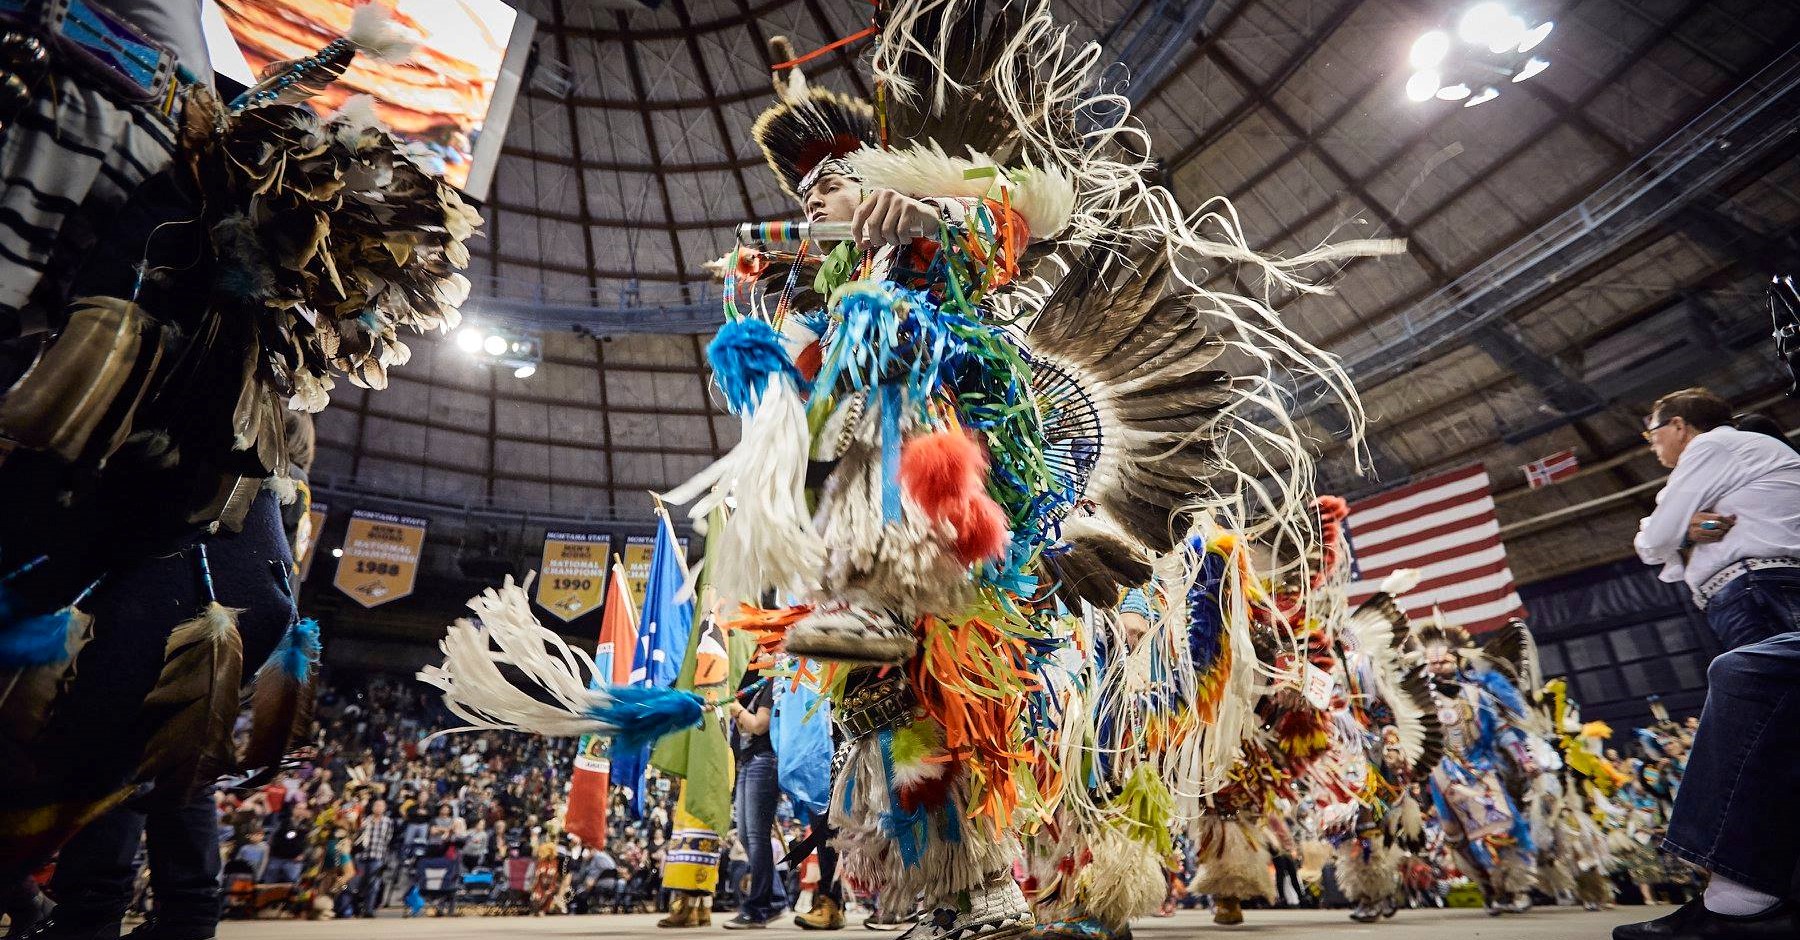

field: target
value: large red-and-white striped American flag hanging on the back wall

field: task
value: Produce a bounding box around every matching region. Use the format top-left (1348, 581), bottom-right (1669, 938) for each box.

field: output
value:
top-left (1348, 465), bottom-right (1525, 634)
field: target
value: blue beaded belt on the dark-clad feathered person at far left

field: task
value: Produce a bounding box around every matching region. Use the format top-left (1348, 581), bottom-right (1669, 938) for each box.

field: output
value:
top-left (0, 0), bottom-right (178, 106)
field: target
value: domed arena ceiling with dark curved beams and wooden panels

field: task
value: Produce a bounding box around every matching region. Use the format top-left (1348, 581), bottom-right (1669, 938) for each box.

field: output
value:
top-left (315, 0), bottom-right (1800, 582)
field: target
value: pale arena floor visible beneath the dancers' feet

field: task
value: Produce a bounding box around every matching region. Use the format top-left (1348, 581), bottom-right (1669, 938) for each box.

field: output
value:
top-left (220, 908), bottom-right (1669, 940)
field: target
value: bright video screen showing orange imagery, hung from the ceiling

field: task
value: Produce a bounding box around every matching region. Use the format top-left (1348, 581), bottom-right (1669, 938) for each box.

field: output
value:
top-left (214, 0), bottom-right (535, 198)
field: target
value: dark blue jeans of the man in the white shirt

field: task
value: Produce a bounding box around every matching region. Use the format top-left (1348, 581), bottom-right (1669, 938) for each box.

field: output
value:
top-left (1663, 569), bottom-right (1800, 895)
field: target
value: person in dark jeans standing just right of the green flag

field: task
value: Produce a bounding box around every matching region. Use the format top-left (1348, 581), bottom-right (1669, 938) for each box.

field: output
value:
top-left (725, 672), bottom-right (787, 931)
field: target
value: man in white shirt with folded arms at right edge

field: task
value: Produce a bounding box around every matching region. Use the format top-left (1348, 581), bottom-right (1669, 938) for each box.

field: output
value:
top-left (1613, 389), bottom-right (1800, 940)
